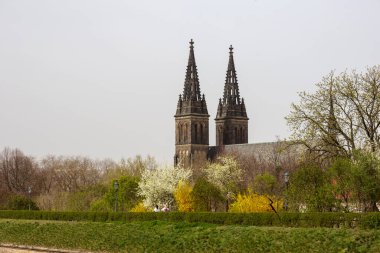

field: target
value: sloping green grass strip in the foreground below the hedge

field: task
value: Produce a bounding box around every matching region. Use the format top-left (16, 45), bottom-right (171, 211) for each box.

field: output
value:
top-left (0, 219), bottom-right (380, 253)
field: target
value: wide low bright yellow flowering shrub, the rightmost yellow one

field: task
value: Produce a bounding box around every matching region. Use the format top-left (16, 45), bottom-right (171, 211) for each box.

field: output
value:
top-left (228, 192), bottom-right (283, 213)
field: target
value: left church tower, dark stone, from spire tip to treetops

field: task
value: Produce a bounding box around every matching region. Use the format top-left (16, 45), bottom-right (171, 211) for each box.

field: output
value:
top-left (174, 40), bottom-right (209, 167)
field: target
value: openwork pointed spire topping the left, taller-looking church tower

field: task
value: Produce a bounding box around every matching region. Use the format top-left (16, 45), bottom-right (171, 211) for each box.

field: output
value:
top-left (183, 39), bottom-right (202, 101)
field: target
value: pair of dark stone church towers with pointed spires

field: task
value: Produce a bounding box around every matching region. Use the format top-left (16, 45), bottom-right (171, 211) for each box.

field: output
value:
top-left (174, 40), bottom-right (255, 167)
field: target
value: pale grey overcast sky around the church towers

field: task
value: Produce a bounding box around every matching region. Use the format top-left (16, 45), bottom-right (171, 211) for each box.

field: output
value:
top-left (0, 0), bottom-right (380, 163)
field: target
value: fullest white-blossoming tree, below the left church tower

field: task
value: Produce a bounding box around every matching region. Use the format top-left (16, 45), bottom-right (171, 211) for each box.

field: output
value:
top-left (138, 166), bottom-right (191, 210)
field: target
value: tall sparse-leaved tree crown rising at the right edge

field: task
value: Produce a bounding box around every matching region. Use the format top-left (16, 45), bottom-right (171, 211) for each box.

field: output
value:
top-left (286, 65), bottom-right (380, 157)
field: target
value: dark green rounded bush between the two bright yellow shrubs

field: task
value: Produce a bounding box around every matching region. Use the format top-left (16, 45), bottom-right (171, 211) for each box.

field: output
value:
top-left (191, 178), bottom-right (224, 211)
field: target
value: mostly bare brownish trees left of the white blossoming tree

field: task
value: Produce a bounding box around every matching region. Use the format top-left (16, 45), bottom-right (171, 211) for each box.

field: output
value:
top-left (0, 148), bottom-right (157, 211)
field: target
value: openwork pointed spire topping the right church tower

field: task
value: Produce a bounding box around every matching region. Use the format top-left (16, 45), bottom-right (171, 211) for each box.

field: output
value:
top-left (223, 45), bottom-right (240, 105)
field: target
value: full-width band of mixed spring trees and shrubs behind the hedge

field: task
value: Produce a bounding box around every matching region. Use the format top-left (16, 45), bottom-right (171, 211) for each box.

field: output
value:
top-left (0, 145), bottom-right (380, 213)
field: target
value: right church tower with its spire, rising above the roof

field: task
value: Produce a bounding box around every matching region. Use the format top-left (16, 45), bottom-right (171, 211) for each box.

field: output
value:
top-left (215, 46), bottom-right (249, 146)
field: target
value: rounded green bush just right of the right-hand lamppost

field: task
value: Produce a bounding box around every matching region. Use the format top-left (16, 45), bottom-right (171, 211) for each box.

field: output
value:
top-left (286, 164), bottom-right (340, 212)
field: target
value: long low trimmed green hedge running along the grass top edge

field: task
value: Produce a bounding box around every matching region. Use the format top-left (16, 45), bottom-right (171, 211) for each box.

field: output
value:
top-left (0, 210), bottom-right (380, 228)
